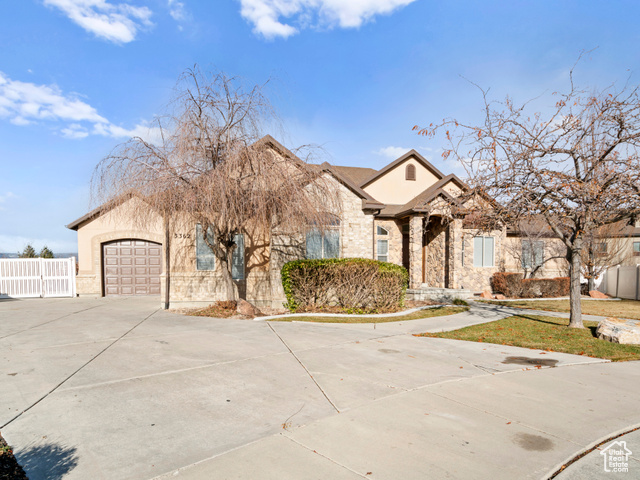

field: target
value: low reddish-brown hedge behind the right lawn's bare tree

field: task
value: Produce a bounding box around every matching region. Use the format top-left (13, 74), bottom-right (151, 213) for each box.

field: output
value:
top-left (491, 272), bottom-right (570, 298)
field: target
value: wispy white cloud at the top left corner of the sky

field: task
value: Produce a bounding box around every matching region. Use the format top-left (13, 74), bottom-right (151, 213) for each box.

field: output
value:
top-left (44, 0), bottom-right (152, 43)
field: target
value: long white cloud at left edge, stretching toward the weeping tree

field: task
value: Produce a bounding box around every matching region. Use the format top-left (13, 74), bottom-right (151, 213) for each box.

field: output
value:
top-left (0, 72), bottom-right (159, 142)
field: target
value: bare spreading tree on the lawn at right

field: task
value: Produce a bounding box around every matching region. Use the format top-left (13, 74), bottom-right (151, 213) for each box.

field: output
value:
top-left (414, 69), bottom-right (640, 328)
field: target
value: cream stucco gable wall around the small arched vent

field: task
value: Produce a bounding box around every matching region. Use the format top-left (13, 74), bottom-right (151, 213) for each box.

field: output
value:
top-left (364, 157), bottom-right (439, 205)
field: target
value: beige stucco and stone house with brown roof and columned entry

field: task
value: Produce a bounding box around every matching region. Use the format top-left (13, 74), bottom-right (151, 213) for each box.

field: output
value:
top-left (67, 136), bottom-right (506, 306)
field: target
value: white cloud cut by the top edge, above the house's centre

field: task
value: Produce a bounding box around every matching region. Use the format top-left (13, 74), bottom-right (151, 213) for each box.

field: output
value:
top-left (240, 0), bottom-right (415, 38)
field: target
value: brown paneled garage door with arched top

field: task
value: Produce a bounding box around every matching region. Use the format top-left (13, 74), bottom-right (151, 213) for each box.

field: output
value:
top-left (102, 240), bottom-right (162, 295)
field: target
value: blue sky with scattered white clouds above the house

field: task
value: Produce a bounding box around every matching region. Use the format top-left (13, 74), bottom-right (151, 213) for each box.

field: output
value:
top-left (0, 0), bottom-right (640, 252)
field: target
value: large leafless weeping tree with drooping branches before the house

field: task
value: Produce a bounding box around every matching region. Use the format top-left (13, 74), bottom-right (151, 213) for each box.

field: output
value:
top-left (92, 67), bottom-right (340, 308)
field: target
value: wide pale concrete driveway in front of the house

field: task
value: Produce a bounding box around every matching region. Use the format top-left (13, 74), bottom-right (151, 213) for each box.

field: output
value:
top-left (0, 298), bottom-right (640, 480)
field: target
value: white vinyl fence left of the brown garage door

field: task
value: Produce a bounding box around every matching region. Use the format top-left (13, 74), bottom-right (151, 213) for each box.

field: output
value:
top-left (0, 257), bottom-right (76, 298)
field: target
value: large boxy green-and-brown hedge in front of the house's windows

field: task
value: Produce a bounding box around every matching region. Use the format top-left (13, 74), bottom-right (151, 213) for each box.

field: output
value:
top-left (281, 258), bottom-right (409, 313)
